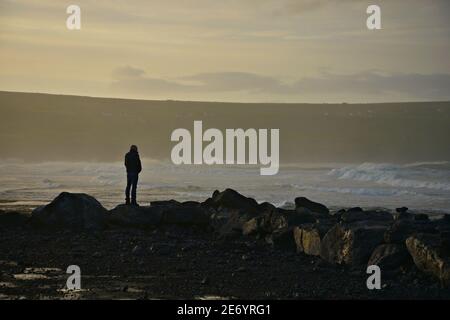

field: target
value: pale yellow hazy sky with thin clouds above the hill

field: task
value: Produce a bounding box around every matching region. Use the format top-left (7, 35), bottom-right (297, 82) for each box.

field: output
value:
top-left (0, 0), bottom-right (450, 103)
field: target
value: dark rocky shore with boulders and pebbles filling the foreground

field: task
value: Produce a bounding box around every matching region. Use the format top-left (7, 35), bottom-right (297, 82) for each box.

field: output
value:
top-left (0, 189), bottom-right (450, 299)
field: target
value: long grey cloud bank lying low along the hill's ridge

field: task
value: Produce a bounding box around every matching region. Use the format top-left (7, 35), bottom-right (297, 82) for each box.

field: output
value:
top-left (111, 67), bottom-right (450, 101)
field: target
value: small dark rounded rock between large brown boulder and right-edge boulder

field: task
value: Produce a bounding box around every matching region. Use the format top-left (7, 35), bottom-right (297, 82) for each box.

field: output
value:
top-left (367, 244), bottom-right (412, 272)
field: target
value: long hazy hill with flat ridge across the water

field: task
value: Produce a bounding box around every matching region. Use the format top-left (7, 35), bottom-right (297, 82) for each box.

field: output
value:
top-left (0, 92), bottom-right (450, 163)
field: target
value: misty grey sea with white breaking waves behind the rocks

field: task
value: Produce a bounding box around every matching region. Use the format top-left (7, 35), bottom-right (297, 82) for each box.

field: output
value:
top-left (0, 159), bottom-right (450, 215)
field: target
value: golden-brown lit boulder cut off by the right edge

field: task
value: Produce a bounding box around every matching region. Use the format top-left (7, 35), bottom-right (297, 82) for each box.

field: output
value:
top-left (406, 234), bottom-right (450, 286)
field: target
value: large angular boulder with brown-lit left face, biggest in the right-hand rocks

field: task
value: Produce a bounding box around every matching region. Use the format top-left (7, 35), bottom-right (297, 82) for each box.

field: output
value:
top-left (320, 223), bottom-right (387, 267)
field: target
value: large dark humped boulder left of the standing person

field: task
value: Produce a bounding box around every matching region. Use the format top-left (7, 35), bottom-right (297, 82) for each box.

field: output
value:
top-left (31, 192), bottom-right (108, 230)
